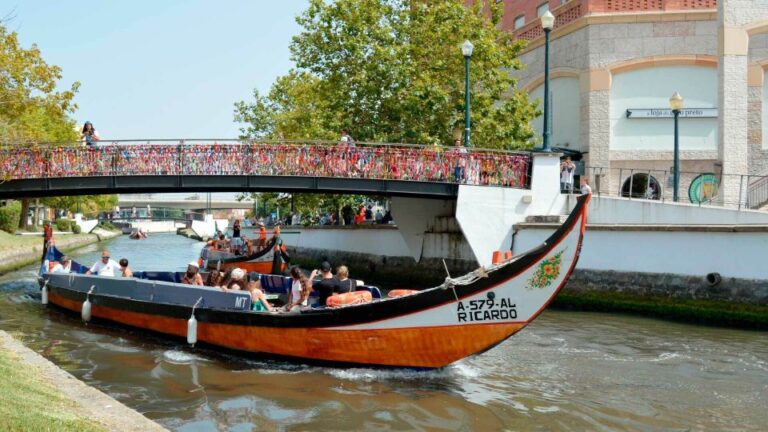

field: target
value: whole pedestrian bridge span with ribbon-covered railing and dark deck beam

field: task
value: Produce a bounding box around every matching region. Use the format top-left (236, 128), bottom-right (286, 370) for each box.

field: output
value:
top-left (0, 140), bottom-right (531, 199)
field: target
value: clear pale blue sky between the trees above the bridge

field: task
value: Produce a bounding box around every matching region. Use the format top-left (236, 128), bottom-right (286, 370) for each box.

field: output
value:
top-left (0, 0), bottom-right (307, 140)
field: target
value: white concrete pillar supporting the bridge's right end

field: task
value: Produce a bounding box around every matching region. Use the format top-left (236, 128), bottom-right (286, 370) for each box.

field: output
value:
top-left (456, 153), bottom-right (567, 266)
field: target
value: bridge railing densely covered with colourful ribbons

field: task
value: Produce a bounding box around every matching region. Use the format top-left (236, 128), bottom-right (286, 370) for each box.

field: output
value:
top-left (0, 141), bottom-right (530, 188)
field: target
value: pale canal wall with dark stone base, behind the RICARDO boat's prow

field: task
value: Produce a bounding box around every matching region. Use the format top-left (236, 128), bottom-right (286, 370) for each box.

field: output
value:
top-left (514, 223), bottom-right (768, 306)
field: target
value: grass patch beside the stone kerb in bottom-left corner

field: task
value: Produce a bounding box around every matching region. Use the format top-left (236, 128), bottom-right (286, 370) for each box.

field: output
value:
top-left (0, 350), bottom-right (104, 431)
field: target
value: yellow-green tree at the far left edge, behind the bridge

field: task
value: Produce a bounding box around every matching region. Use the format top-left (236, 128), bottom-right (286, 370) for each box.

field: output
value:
top-left (0, 23), bottom-right (80, 229)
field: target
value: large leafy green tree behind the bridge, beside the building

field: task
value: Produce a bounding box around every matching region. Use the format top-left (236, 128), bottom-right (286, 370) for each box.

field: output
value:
top-left (235, 0), bottom-right (539, 149)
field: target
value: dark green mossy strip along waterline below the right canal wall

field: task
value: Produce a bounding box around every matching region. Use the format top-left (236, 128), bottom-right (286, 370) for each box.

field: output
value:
top-left (552, 291), bottom-right (768, 330)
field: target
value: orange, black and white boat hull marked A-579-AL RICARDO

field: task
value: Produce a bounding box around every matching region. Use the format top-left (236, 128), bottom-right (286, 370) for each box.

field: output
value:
top-left (41, 195), bottom-right (589, 369)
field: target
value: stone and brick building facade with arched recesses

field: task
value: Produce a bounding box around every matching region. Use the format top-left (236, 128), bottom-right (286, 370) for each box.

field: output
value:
top-left (491, 0), bottom-right (768, 208)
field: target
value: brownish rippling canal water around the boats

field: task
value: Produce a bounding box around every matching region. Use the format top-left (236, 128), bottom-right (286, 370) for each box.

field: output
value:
top-left (0, 235), bottom-right (768, 431)
